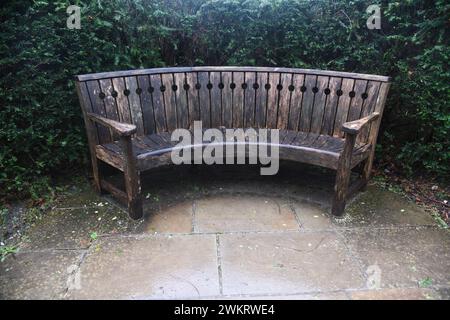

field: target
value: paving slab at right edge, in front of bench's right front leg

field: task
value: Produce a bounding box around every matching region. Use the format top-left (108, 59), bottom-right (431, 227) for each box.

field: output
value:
top-left (343, 227), bottom-right (450, 288)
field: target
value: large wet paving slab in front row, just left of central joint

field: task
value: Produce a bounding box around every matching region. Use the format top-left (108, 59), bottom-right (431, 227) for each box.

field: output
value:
top-left (69, 235), bottom-right (220, 299)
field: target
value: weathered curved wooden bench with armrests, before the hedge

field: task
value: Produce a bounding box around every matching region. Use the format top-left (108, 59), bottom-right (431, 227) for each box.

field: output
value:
top-left (76, 67), bottom-right (390, 219)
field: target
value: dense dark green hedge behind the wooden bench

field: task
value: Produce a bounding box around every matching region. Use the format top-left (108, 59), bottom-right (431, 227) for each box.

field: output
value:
top-left (0, 0), bottom-right (450, 196)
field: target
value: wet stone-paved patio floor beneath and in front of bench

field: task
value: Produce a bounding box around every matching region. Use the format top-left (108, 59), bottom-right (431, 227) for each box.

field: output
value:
top-left (0, 163), bottom-right (450, 299)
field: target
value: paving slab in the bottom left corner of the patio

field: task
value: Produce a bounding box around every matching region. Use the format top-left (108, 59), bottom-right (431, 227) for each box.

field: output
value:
top-left (0, 250), bottom-right (84, 299)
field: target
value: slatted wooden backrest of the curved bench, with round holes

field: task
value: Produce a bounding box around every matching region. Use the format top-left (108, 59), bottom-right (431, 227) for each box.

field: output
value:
top-left (77, 67), bottom-right (389, 143)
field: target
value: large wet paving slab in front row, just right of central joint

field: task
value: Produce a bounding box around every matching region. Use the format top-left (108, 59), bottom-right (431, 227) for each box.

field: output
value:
top-left (219, 232), bottom-right (365, 295)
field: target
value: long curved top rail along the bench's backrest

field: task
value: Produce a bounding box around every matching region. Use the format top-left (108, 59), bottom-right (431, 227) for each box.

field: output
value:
top-left (77, 67), bottom-right (391, 82)
